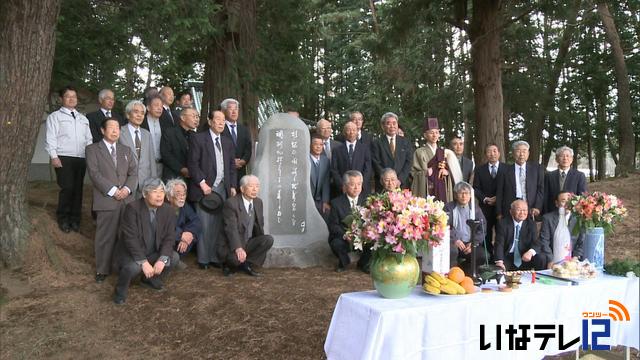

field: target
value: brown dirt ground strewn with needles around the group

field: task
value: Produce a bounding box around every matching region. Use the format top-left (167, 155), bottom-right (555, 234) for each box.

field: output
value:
top-left (0, 175), bottom-right (640, 359)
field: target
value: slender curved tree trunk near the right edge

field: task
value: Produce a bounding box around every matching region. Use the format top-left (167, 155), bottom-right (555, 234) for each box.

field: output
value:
top-left (598, 2), bottom-right (635, 177)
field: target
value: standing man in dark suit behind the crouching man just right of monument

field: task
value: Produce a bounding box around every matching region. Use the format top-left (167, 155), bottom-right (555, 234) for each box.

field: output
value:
top-left (331, 121), bottom-right (373, 198)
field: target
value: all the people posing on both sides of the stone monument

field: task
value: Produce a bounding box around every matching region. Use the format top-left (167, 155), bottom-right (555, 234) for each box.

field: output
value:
top-left (46, 87), bottom-right (586, 304)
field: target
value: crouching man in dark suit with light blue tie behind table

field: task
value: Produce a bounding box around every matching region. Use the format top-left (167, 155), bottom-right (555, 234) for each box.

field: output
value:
top-left (493, 200), bottom-right (547, 271)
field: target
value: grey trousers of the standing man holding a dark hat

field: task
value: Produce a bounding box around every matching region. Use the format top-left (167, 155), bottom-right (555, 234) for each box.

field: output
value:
top-left (196, 182), bottom-right (227, 264)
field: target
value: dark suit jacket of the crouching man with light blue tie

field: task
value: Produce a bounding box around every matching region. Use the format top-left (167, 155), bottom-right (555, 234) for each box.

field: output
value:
top-left (493, 216), bottom-right (542, 261)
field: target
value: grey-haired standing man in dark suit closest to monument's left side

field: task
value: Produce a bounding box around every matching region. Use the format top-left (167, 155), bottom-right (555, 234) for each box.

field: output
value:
top-left (220, 99), bottom-right (253, 186)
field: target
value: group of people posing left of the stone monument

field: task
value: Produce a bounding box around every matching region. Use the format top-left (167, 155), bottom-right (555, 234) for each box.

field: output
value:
top-left (45, 86), bottom-right (273, 304)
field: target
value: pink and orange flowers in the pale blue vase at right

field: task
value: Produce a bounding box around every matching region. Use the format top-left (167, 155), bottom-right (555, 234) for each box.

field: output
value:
top-left (566, 191), bottom-right (627, 234)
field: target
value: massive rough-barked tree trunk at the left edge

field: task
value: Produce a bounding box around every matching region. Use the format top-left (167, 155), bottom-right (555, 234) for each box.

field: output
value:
top-left (0, 0), bottom-right (60, 267)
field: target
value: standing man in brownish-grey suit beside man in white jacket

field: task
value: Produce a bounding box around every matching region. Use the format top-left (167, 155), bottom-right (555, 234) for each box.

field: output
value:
top-left (85, 118), bottom-right (138, 283)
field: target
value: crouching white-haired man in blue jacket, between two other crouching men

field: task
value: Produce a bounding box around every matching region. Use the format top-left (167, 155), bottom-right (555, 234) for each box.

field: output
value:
top-left (167, 177), bottom-right (202, 267)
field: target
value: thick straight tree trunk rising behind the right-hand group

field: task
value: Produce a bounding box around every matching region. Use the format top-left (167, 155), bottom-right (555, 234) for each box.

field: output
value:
top-left (469, 0), bottom-right (505, 163)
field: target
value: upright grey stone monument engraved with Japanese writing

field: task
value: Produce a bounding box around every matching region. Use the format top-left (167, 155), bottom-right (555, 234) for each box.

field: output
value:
top-left (252, 113), bottom-right (334, 267)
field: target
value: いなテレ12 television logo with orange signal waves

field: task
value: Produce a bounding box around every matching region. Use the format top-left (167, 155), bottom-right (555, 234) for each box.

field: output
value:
top-left (480, 300), bottom-right (631, 351)
